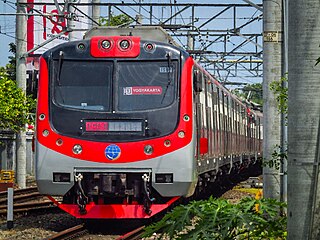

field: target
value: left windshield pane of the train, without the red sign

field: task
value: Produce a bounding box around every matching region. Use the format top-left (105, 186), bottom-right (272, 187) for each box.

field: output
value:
top-left (53, 60), bottom-right (113, 111)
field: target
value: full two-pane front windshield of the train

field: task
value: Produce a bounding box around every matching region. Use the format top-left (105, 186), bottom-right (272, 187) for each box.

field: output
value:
top-left (53, 59), bottom-right (178, 112)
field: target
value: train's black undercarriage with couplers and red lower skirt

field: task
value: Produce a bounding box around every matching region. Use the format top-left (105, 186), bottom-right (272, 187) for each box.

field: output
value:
top-left (52, 157), bottom-right (261, 219)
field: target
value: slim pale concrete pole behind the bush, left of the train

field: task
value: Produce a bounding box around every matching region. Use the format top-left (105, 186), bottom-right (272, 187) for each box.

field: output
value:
top-left (16, 0), bottom-right (27, 188)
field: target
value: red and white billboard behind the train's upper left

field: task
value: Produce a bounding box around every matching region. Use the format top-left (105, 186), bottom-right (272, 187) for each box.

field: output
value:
top-left (27, 0), bottom-right (91, 54)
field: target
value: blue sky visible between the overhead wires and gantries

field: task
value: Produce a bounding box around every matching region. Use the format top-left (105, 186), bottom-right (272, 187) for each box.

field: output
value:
top-left (0, 0), bottom-right (262, 83)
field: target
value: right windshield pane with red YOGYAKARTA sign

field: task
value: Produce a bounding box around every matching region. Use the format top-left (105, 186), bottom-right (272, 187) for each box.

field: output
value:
top-left (117, 61), bottom-right (178, 111)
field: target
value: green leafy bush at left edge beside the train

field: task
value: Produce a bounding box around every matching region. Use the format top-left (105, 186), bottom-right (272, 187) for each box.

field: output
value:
top-left (0, 71), bottom-right (35, 132)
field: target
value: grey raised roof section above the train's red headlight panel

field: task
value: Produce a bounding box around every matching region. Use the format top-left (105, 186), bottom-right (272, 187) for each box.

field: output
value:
top-left (84, 26), bottom-right (181, 47)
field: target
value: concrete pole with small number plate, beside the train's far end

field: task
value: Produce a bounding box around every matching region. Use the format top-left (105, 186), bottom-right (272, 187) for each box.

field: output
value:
top-left (263, 0), bottom-right (282, 200)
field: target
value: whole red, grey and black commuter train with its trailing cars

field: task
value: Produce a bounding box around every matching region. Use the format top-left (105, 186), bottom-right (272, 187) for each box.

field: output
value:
top-left (35, 28), bottom-right (262, 219)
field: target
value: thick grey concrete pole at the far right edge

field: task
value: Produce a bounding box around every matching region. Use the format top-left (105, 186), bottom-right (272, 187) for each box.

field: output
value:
top-left (287, 0), bottom-right (320, 240)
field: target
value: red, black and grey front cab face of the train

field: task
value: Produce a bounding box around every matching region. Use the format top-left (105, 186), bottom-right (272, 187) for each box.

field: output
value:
top-left (36, 34), bottom-right (197, 219)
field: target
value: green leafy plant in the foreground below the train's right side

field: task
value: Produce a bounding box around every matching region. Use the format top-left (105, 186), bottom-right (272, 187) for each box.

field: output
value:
top-left (145, 197), bottom-right (286, 240)
